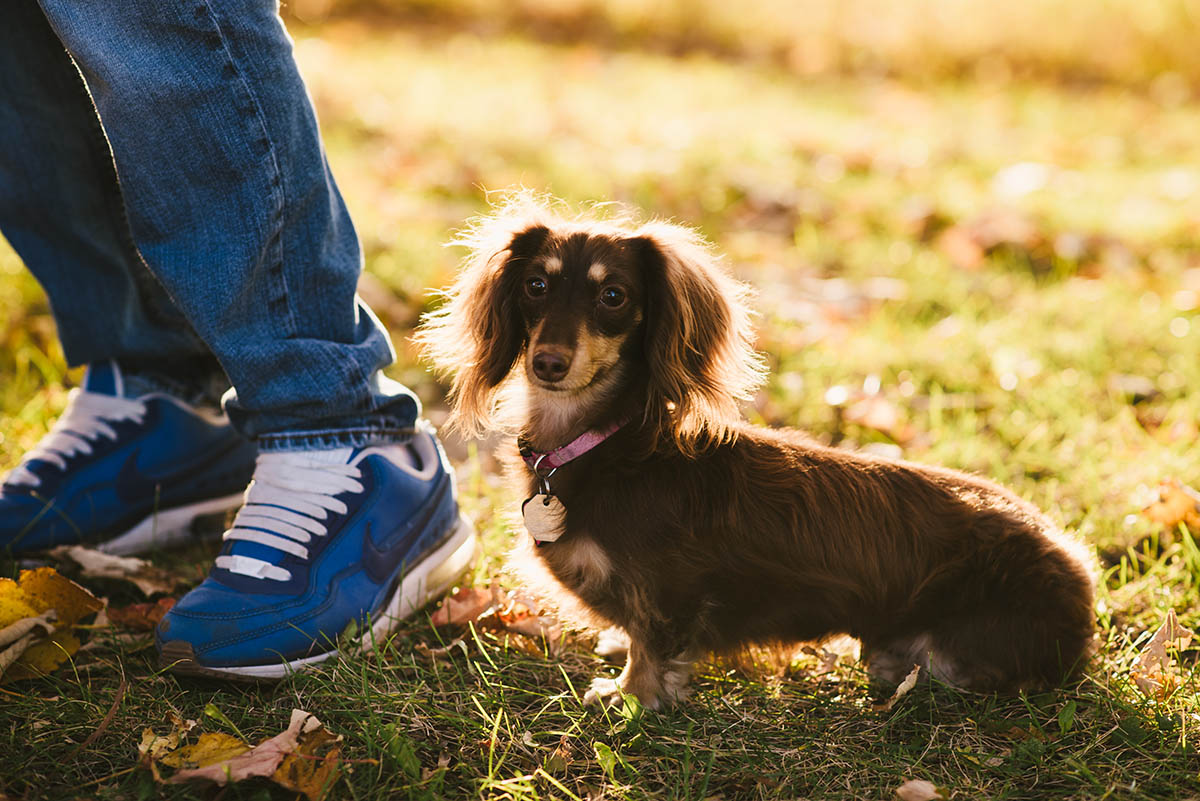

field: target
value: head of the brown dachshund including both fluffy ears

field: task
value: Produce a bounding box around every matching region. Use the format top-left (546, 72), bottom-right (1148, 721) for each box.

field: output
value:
top-left (418, 196), bottom-right (762, 450)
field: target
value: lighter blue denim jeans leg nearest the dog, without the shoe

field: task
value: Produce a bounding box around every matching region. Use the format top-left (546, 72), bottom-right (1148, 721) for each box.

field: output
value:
top-left (42, 0), bottom-right (419, 450)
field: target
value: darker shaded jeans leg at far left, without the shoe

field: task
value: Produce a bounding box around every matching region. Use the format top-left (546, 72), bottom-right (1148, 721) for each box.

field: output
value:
top-left (0, 0), bottom-right (215, 374)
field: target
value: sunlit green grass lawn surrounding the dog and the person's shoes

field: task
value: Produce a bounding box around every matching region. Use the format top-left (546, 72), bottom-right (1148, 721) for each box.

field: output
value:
top-left (0, 2), bottom-right (1200, 800)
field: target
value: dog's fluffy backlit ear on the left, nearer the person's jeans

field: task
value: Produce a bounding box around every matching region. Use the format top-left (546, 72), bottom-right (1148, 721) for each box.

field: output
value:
top-left (415, 223), bottom-right (550, 435)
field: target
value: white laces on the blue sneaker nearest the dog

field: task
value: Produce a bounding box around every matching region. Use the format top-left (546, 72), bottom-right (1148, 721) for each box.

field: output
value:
top-left (216, 448), bottom-right (364, 582)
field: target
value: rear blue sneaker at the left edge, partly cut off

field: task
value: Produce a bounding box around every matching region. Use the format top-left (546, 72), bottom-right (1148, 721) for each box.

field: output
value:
top-left (0, 362), bottom-right (257, 555)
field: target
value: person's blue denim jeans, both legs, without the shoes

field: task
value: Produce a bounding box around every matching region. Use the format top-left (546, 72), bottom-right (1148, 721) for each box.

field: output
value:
top-left (0, 0), bottom-right (420, 450)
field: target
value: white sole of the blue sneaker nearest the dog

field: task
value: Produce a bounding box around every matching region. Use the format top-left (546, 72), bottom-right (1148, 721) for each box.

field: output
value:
top-left (160, 514), bottom-right (480, 681)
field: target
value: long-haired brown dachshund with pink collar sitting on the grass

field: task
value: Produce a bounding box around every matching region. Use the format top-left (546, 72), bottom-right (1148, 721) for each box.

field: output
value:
top-left (418, 201), bottom-right (1093, 709)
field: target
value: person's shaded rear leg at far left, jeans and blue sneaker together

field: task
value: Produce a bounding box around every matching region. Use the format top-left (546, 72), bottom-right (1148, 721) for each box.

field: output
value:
top-left (0, 0), bottom-right (256, 553)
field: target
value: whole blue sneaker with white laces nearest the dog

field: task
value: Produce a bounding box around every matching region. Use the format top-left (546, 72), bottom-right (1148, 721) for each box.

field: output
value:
top-left (155, 427), bottom-right (476, 680)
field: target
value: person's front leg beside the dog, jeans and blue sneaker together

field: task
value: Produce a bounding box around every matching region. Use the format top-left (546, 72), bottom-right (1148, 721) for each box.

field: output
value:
top-left (28, 0), bottom-right (475, 677)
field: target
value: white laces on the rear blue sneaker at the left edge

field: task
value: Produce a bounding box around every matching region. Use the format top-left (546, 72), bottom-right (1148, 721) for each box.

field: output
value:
top-left (5, 389), bottom-right (146, 487)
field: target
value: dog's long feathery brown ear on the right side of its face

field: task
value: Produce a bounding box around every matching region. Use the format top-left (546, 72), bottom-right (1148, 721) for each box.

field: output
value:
top-left (630, 223), bottom-right (763, 452)
